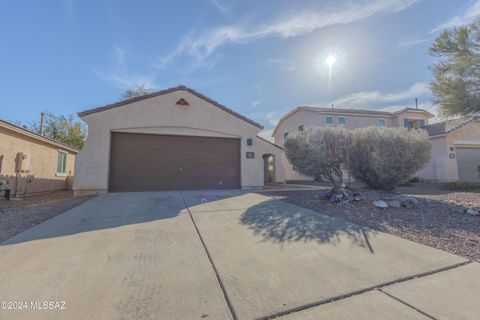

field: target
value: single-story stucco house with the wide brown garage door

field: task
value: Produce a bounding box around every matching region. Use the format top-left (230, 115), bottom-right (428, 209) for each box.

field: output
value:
top-left (73, 86), bottom-right (284, 195)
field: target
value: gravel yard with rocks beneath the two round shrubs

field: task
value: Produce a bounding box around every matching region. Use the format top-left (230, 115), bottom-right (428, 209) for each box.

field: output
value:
top-left (262, 183), bottom-right (480, 260)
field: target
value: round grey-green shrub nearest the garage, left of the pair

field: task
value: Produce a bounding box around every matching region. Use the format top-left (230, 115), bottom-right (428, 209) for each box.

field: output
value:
top-left (284, 127), bottom-right (352, 186)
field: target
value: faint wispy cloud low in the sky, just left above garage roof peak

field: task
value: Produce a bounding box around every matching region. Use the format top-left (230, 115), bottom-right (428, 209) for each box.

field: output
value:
top-left (93, 47), bottom-right (157, 90)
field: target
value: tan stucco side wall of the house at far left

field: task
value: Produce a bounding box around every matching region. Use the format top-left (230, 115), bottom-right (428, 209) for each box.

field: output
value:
top-left (0, 127), bottom-right (75, 196)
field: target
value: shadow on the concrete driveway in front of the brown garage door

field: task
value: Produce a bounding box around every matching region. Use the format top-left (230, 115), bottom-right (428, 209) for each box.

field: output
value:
top-left (0, 190), bottom-right (251, 247)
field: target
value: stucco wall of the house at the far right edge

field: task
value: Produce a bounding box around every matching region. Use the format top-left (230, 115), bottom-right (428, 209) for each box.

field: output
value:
top-left (417, 120), bottom-right (480, 181)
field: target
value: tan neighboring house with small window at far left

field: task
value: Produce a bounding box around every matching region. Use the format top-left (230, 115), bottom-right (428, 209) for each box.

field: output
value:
top-left (0, 120), bottom-right (78, 197)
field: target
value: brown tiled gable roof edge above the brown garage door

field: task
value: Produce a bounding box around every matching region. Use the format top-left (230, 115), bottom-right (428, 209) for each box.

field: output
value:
top-left (78, 86), bottom-right (263, 129)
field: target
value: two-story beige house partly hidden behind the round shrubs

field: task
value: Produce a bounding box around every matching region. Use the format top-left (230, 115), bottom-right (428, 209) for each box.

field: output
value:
top-left (272, 106), bottom-right (434, 181)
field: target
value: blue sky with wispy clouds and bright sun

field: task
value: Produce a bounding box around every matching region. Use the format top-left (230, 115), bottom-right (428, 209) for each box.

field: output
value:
top-left (0, 0), bottom-right (480, 135)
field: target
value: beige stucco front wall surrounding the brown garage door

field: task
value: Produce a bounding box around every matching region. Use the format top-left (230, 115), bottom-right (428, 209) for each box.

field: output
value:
top-left (73, 90), bottom-right (282, 194)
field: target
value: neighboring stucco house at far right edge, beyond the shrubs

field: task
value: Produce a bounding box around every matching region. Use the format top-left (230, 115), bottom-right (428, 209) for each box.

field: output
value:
top-left (417, 115), bottom-right (480, 181)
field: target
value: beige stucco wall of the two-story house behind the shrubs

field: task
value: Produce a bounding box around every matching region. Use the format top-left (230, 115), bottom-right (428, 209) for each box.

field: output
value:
top-left (274, 109), bottom-right (434, 181)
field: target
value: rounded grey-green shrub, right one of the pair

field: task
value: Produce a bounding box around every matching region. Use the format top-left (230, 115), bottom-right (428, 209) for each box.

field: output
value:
top-left (350, 127), bottom-right (431, 190)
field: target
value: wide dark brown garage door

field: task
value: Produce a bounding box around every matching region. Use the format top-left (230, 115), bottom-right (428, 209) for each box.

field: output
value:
top-left (109, 133), bottom-right (240, 191)
